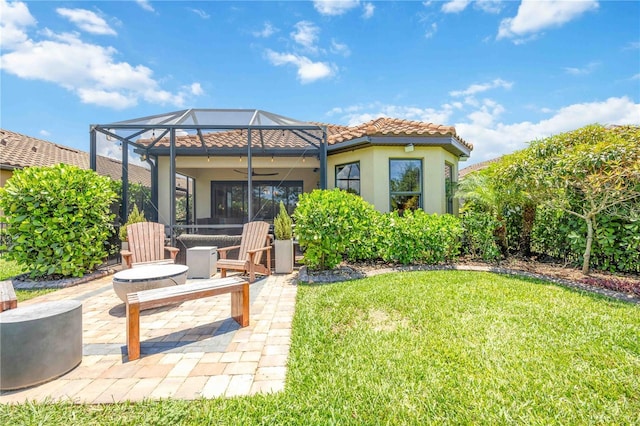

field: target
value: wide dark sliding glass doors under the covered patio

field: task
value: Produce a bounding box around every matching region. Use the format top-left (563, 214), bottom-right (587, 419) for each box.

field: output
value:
top-left (211, 181), bottom-right (302, 223)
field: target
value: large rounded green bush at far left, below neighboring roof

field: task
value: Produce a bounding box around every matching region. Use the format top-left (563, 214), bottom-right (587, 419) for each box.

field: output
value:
top-left (0, 164), bottom-right (116, 278)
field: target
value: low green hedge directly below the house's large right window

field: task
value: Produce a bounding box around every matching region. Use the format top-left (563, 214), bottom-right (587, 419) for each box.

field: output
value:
top-left (380, 210), bottom-right (462, 265)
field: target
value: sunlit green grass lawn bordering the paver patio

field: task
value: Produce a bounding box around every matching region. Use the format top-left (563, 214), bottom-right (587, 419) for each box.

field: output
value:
top-left (0, 271), bottom-right (640, 425)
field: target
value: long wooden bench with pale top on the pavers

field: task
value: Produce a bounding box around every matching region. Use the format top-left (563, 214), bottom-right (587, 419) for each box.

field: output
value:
top-left (126, 277), bottom-right (249, 361)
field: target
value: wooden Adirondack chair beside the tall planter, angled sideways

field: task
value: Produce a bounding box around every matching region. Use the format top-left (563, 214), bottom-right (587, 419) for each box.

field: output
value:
top-left (216, 221), bottom-right (271, 283)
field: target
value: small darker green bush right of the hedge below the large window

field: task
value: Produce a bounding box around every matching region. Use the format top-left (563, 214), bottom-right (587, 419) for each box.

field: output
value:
top-left (461, 211), bottom-right (501, 262)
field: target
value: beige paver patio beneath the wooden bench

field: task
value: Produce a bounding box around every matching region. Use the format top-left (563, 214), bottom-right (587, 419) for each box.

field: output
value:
top-left (0, 275), bottom-right (297, 404)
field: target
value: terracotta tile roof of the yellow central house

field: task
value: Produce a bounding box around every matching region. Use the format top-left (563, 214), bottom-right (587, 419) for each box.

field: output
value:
top-left (138, 117), bottom-right (473, 154)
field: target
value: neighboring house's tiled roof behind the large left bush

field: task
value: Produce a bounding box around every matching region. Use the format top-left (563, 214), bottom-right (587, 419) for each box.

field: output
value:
top-left (0, 129), bottom-right (151, 187)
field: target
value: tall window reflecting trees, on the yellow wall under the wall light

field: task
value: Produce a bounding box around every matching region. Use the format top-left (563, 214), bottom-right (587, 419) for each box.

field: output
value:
top-left (389, 159), bottom-right (422, 213)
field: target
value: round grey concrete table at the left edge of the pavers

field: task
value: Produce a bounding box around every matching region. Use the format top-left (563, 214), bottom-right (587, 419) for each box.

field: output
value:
top-left (0, 300), bottom-right (82, 390)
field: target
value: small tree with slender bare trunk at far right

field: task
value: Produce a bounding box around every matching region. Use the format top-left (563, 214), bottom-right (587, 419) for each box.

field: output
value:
top-left (520, 125), bottom-right (640, 274)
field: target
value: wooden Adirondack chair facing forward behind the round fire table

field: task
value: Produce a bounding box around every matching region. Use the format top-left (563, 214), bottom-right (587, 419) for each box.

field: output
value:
top-left (120, 222), bottom-right (180, 268)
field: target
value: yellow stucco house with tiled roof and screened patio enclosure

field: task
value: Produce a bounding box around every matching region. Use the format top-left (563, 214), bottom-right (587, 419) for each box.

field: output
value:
top-left (91, 109), bottom-right (473, 236)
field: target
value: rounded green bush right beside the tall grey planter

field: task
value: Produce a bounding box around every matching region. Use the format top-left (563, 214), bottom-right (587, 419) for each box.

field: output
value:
top-left (293, 189), bottom-right (379, 270)
